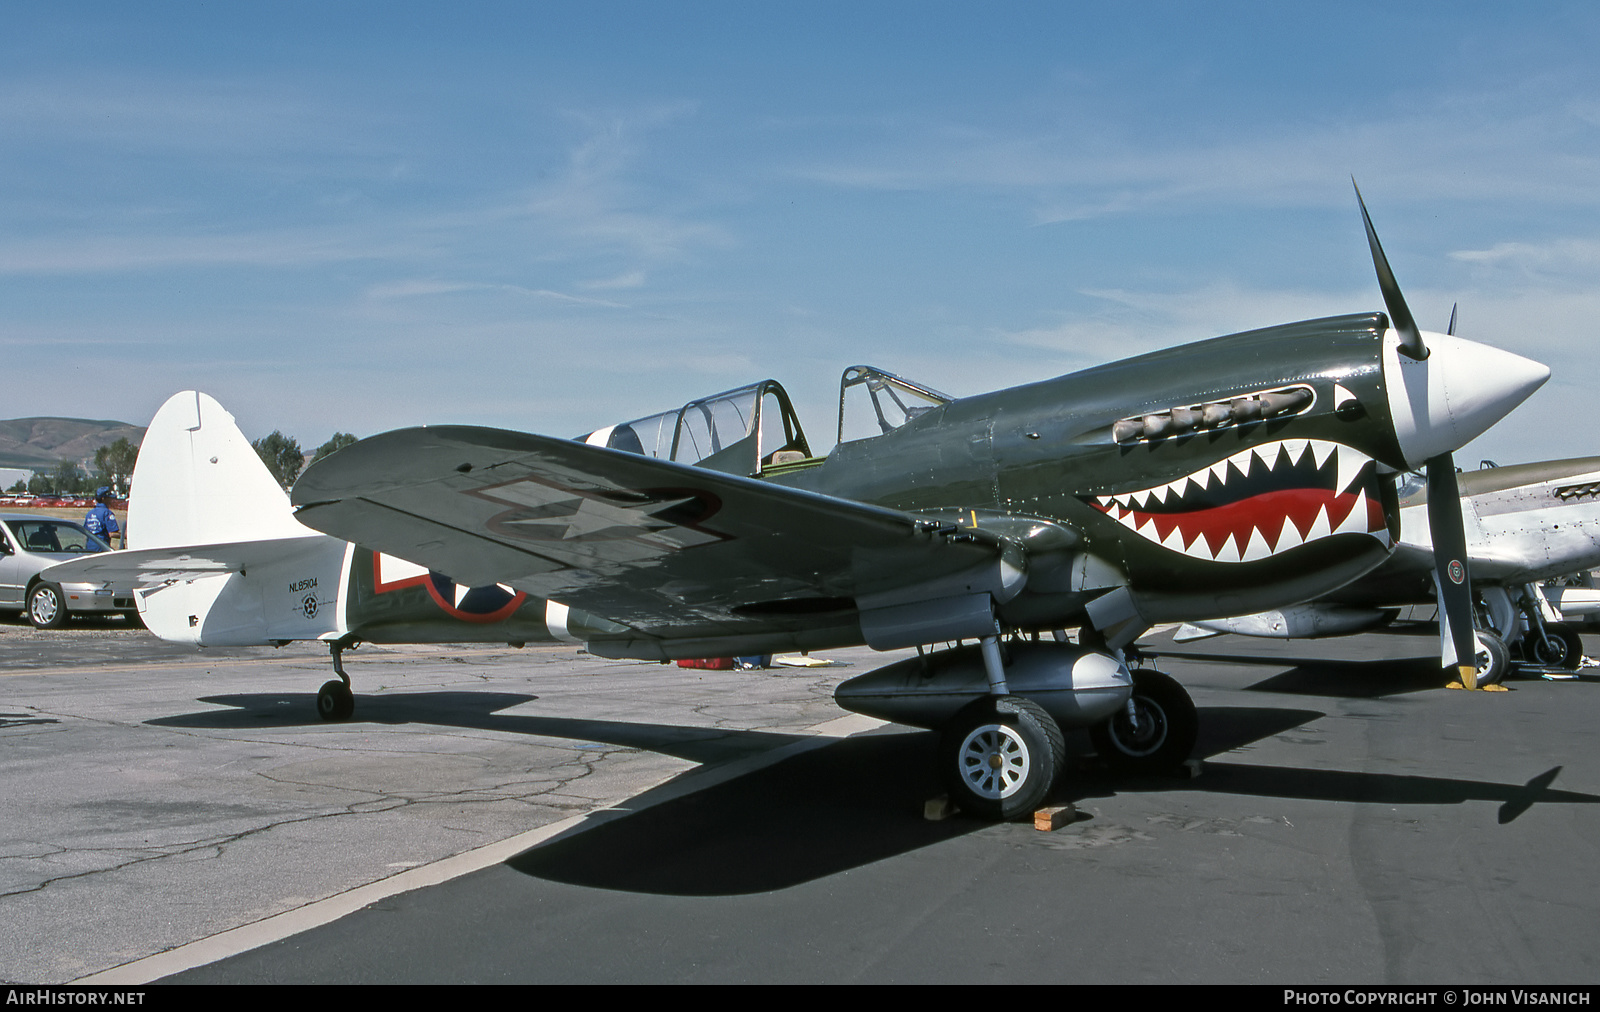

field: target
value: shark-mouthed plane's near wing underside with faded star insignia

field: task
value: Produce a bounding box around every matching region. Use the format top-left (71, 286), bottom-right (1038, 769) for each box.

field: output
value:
top-left (291, 426), bottom-right (1014, 639)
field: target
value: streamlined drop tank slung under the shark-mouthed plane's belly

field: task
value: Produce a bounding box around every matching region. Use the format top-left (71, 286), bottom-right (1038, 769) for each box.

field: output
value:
top-left (834, 642), bottom-right (1133, 729)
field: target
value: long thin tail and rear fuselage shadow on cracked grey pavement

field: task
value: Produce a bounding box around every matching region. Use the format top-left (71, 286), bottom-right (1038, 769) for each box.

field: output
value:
top-left (146, 692), bottom-right (810, 762)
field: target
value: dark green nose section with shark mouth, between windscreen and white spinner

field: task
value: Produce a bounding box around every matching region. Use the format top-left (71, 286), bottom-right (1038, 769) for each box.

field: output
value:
top-left (773, 314), bottom-right (1402, 628)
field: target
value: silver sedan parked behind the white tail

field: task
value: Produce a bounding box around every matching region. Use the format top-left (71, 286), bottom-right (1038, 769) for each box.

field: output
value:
top-left (0, 514), bottom-right (138, 629)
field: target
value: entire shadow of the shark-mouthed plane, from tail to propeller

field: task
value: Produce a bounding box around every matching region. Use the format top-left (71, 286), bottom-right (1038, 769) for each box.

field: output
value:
top-left (147, 692), bottom-right (1600, 895)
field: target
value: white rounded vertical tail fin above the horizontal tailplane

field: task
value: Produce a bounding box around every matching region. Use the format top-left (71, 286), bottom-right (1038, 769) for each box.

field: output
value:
top-left (128, 391), bottom-right (317, 549)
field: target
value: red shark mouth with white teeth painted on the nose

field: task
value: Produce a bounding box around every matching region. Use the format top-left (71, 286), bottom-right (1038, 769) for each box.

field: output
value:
top-left (1082, 439), bottom-right (1389, 562)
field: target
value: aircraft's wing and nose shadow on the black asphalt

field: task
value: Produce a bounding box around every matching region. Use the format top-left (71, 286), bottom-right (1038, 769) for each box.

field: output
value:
top-left (507, 708), bottom-right (1600, 895)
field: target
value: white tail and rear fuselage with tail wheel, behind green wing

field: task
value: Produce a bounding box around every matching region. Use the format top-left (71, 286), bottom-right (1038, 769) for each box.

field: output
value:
top-left (50, 391), bottom-right (606, 721)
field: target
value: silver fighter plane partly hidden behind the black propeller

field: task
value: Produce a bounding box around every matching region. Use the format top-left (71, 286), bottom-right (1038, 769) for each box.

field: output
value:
top-left (1176, 456), bottom-right (1600, 684)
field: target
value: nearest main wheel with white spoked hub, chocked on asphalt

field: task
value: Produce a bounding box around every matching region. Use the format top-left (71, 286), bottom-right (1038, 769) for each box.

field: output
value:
top-left (939, 695), bottom-right (1067, 821)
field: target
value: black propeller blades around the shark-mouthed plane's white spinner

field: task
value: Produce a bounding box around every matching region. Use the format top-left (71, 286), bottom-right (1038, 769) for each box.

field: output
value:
top-left (1350, 179), bottom-right (1478, 689)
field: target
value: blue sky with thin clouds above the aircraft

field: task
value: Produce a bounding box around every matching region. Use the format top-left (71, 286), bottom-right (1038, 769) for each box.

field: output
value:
top-left (0, 2), bottom-right (1600, 466)
